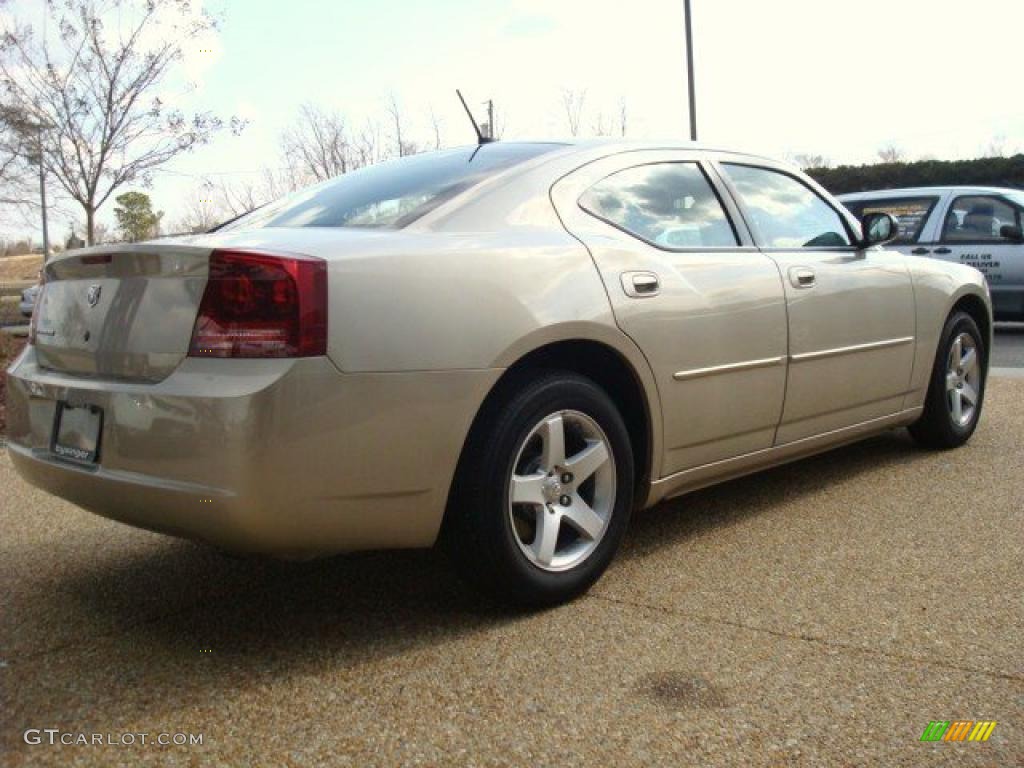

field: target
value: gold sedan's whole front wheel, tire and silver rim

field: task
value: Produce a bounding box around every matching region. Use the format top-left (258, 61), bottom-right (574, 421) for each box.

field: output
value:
top-left (910, 312), bottom-right (987, 449)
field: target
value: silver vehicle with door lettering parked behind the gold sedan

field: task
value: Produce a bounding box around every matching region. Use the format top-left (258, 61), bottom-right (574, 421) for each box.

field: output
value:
top-left (839, 186), bottom-right (1024, 321)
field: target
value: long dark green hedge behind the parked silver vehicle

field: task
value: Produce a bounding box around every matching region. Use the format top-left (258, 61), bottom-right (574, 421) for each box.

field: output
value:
top-left (807, 155), bottom-right (1024, 195)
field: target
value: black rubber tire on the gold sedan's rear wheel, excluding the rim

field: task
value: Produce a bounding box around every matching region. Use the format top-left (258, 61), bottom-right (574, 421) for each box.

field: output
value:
top-left (442, 372), bottom-right (634, 607)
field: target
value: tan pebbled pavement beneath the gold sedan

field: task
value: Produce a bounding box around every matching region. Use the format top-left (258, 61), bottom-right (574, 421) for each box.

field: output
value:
top-left (0, 379), bottom-right (1024, 766)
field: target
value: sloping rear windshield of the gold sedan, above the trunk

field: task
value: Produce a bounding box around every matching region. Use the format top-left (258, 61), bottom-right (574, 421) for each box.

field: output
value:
top-left (220, 142), bottom-right (560, 231)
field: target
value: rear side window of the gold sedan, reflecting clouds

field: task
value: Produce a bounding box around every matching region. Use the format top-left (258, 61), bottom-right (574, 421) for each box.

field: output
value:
top-left (580, 163), bottom-right (738, 249)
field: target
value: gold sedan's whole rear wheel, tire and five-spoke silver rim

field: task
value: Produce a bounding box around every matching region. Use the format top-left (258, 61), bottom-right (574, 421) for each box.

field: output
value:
top-left (445, 373), bottom-right (633, 605)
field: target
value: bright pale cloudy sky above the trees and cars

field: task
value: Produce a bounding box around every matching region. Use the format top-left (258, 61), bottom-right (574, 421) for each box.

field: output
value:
top-left (0, 0), bottom-right (1024, 239)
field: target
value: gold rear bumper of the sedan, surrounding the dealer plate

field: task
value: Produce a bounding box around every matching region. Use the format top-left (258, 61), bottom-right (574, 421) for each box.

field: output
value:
top-left (7, 347), bottom-right (501, 557)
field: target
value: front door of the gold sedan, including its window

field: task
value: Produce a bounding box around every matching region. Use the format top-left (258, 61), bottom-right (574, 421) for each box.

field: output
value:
top-left (721, 160), bottom-right (914, 444)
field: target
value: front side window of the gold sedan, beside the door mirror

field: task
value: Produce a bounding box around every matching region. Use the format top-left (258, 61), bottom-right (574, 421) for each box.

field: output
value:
top-left (722, 163), bottom-right (850, 248)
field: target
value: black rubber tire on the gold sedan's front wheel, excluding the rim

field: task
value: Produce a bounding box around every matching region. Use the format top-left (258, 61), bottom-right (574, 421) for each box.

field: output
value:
top-left (909, 311), bottom-right (988, 451)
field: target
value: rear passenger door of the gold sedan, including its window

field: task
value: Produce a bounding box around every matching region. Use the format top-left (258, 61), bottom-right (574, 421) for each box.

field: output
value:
top-left (552, 151), bottom-right (786, 475)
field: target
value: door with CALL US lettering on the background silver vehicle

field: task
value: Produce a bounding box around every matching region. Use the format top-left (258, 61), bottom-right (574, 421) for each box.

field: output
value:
top-left (929, 193), bottom-right (1024, 318)
